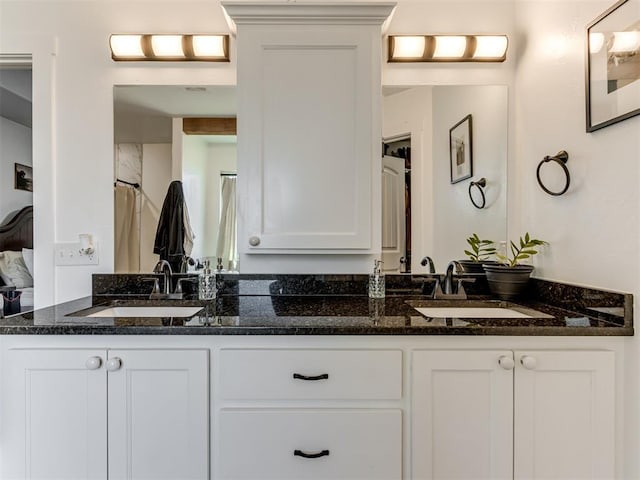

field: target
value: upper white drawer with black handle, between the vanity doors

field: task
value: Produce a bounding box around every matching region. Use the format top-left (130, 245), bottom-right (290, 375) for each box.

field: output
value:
top-left (220, 349), bottom-right (402, 400)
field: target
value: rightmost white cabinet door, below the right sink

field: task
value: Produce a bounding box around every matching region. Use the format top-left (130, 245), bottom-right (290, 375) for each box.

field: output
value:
top-left (514, 351), bottom-right (615, 480)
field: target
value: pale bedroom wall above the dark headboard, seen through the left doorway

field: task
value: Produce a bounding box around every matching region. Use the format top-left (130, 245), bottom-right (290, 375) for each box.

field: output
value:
top-left (0, 117), bottom-right (33, 222)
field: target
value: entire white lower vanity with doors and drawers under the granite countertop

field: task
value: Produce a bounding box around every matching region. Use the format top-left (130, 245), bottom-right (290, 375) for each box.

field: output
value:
top-left (0, 335), bottom-right (628, 480)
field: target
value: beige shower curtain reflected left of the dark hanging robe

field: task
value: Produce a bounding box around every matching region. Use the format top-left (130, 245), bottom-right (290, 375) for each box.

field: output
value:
top-left (114, 185), bottom-right (140, 273)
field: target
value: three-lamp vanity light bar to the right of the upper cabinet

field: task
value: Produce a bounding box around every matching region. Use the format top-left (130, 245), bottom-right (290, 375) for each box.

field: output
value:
top-left (387, 35), bottom-right (509, 62)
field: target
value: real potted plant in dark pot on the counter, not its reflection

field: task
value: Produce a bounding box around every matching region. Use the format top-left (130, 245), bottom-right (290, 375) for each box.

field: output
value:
top-left (483, 232), bottom-right (547, 300)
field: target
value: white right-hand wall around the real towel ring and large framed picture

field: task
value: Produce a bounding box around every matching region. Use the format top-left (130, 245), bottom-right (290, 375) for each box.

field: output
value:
top-left (510, 0), bottom-right (640, 291)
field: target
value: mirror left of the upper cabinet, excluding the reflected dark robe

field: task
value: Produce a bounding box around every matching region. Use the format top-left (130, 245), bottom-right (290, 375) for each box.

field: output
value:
top-left (114, 85), bottom-right (237, 273)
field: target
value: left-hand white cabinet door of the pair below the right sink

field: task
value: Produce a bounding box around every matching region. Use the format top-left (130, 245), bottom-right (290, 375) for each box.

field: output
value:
top-left (411, 350), bottom-right (513, 480)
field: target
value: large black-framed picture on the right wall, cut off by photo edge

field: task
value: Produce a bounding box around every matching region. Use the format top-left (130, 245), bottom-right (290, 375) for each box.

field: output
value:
top-left (586, 0), bottom-right (640, 132)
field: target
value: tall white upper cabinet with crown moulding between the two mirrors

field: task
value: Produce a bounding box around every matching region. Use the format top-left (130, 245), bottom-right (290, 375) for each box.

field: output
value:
top-left (223, 2), bottom-right (394, 254)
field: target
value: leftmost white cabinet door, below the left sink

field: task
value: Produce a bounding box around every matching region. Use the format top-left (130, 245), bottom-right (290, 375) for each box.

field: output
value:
top-left (0, 349), bottom-right (107, 480)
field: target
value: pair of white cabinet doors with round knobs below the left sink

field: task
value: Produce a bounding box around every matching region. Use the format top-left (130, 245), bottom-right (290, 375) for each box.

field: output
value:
top-left (0, 348), bottom-right (209, 480)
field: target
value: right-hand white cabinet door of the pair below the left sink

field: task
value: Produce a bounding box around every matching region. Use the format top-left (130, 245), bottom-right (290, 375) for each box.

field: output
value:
top-left (106, 350), bottom-right (209, 480)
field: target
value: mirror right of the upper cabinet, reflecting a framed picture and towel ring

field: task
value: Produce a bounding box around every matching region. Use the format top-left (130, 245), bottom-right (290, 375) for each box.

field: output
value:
top-left (382, 85), bottom-right (508, 273)
